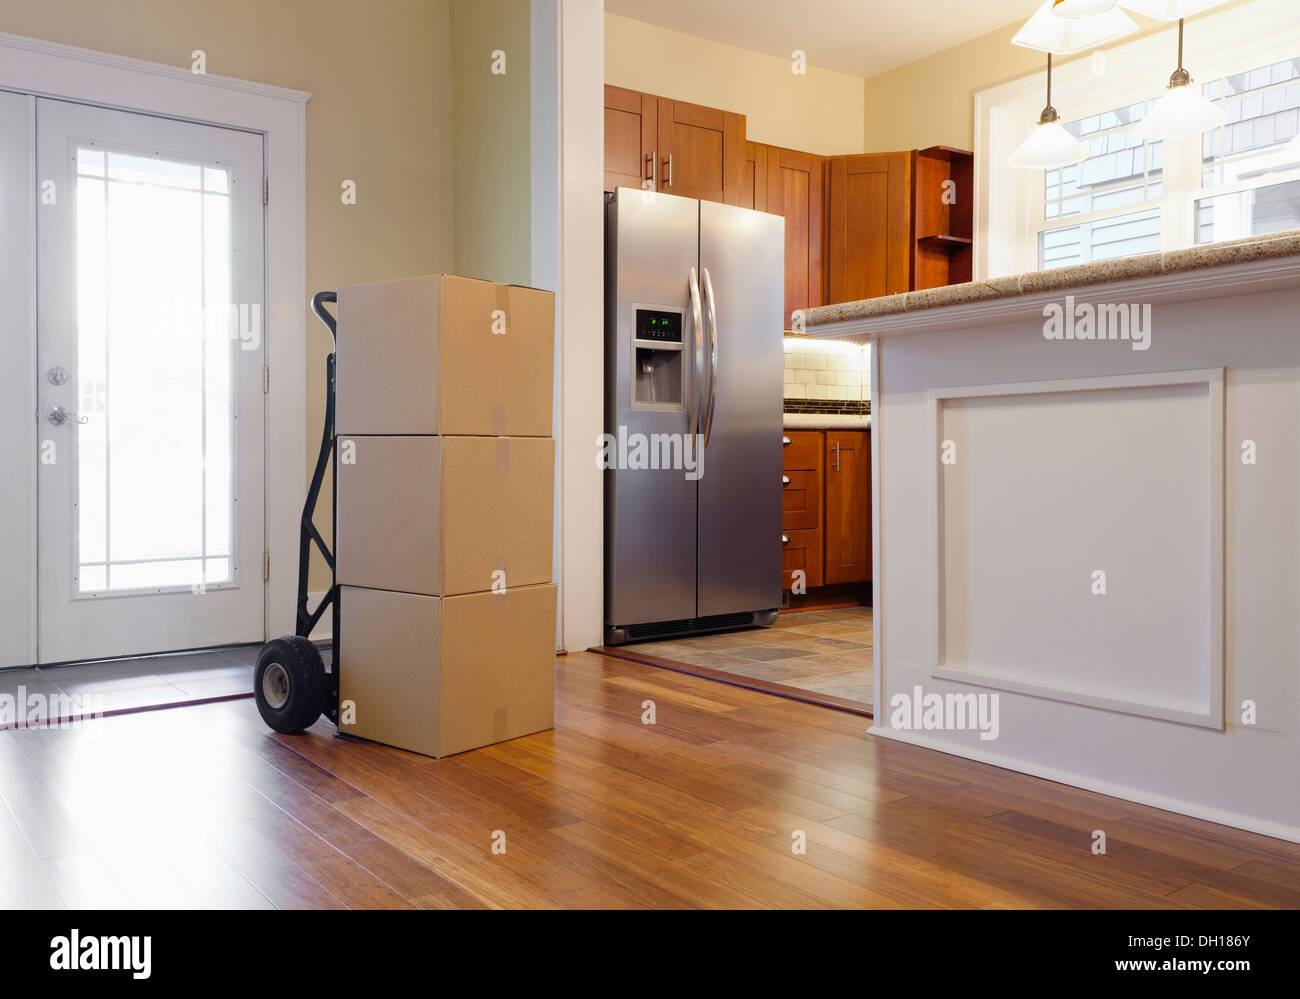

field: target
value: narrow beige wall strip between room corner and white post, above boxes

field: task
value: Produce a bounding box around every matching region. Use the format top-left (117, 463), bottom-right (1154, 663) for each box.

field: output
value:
top-left (451, 0), bottom-right (532, 285)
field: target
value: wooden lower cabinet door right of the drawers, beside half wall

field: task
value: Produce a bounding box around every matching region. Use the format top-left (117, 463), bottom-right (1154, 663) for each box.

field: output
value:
top-left (823, 431), bottom-right (871, 585)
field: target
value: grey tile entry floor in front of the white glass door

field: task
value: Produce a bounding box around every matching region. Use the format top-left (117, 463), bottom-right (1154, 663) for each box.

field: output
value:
top-left (0, 645), bottom-right (269, 712)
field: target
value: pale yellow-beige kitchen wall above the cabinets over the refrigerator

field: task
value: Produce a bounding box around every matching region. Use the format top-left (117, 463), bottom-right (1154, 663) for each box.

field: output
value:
top-left (605, 13), bottom-right (863, 156)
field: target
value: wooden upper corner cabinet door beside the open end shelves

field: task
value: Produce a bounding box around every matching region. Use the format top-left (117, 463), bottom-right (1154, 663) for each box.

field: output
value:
top-left (826, 152), bottom-right (911, 304)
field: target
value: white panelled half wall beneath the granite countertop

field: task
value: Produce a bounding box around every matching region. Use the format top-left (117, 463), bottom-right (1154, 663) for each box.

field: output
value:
top-left (872, 277), bottom-right (1300, 842)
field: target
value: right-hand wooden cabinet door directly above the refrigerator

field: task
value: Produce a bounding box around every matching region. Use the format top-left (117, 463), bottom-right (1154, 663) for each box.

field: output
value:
top-left (659, 98), bottom-right (745, 206)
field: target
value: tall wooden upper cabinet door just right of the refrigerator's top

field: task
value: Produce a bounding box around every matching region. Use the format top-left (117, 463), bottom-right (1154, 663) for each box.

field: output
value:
top-left (764, 146), bottom-right (826, 329)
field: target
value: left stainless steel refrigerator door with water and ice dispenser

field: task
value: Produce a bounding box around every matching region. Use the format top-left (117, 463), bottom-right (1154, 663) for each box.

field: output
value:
top-left (605, 187), bottom-right (702, 626)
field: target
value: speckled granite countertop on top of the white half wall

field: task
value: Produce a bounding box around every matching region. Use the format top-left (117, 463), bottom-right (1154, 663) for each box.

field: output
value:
top-left (806, 229), bottom-right (1300, 325)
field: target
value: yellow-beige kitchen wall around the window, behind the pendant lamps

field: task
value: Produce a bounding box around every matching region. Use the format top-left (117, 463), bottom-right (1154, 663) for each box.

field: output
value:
top-left (863, 0), bottom-right (1251, 152)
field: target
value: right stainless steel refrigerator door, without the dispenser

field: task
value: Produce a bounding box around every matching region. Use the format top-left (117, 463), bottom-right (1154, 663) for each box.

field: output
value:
top-left (697, 202), bottom-right (785, 617)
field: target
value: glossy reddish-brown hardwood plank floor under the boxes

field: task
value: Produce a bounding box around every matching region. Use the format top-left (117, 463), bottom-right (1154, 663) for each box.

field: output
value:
top-left (0, 653), bottom-right (1300, 908)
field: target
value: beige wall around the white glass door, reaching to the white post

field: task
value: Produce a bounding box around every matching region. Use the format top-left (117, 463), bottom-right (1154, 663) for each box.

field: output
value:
top-left (0, 0), bottom-right (529, 591)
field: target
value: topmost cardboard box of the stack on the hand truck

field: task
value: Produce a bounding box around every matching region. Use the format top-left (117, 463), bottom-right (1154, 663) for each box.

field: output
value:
top-left (335, 274), bottom-right (555, 437)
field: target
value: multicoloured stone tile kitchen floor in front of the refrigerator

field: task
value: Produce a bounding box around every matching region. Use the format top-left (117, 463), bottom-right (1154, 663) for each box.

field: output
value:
top-left (625, 607), bottom-right (874, 706)
